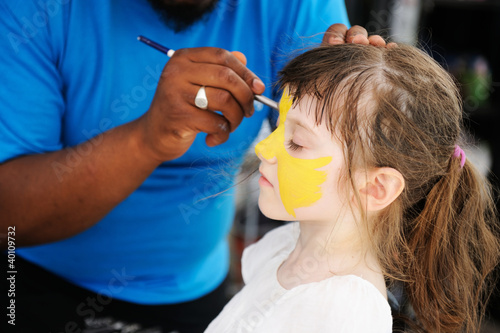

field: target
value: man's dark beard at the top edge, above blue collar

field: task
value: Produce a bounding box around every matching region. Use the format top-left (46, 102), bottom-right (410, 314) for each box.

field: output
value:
top-left (148, 0), bottom-right (218, 32)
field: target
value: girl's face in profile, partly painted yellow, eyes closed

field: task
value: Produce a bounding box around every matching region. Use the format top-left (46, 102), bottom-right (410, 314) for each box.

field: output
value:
top-left (255, 92), bottom-right (347, 221)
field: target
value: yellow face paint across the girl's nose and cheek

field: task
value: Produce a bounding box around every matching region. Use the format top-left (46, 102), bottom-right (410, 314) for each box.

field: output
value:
top-left (255, 91), bottom-right (332, 217)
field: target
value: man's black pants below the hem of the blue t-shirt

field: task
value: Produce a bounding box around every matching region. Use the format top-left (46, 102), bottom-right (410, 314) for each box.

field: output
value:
top-left (2, 256), bottom-right (227, 333)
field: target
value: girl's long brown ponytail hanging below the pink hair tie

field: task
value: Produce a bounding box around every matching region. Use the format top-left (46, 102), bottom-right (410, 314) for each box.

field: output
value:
top-left (404, 158), bottom-right (499, 333)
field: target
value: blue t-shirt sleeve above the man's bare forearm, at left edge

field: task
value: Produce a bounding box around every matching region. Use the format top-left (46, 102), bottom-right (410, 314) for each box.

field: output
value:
top-left (0, 0), bottom-right (65, 162)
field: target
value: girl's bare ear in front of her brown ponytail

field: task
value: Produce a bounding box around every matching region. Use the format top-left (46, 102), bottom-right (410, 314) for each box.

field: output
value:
top-left (358, 167), bottom-right (405, 212)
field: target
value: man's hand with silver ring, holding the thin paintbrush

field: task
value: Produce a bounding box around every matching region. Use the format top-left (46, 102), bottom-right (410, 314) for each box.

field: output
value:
top-left (135, 47), bottom-right (265, 162)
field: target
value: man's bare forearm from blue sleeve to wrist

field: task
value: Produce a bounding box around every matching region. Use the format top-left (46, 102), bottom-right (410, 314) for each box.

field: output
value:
top-left (0, 116), bottom-right (158, 246)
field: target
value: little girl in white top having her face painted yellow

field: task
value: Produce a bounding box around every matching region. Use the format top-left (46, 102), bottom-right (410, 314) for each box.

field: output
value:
top-left (206, 44), bottom-right (499, 333)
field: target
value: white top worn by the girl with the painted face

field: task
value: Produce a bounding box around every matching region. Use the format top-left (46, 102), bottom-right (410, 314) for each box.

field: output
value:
top-left (205, 222), bottom-right (392, 333)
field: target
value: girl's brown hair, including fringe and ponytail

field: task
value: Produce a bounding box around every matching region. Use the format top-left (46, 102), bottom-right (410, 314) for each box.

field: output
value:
top-left (279, 44), bottom-right (499, 333)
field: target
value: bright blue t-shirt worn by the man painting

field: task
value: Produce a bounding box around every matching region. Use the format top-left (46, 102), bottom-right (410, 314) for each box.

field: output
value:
top-left (0, 0), bottom-right (348, 304)
